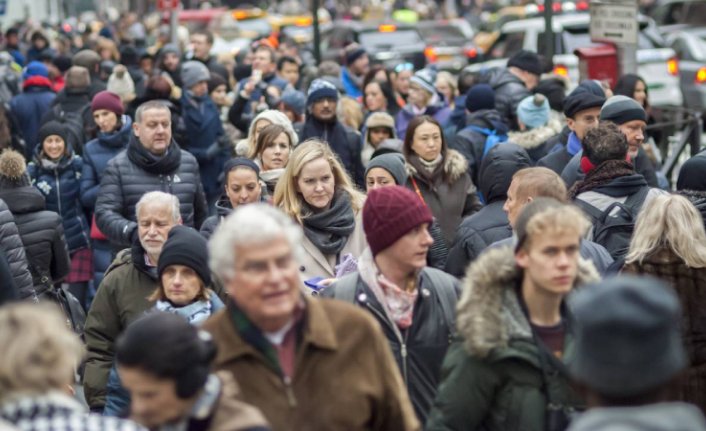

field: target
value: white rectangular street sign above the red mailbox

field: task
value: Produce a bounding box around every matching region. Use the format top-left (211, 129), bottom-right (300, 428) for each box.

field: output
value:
top-left (590, 1), bottom-right (639, 45)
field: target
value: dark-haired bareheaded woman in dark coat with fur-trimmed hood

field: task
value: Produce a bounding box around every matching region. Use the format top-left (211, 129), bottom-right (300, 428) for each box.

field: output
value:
top-left (403, 115), bottom-right (481, 246)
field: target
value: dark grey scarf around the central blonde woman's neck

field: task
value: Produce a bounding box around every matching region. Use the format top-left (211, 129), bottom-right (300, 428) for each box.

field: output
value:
top-left (303, 192), bottom-right (355, 255)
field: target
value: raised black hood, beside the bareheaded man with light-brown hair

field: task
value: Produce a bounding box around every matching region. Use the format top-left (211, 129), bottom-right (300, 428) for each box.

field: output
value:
top-left (478, 144), bottom-right (532, 203)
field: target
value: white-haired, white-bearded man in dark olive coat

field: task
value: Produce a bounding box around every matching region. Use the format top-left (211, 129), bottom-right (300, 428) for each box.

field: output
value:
top-left (84, 192), bottom-right (182, 411)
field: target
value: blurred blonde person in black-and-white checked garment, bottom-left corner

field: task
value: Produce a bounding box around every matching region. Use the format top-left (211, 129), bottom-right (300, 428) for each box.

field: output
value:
top-left (0, 303), bottom-right (143, 431)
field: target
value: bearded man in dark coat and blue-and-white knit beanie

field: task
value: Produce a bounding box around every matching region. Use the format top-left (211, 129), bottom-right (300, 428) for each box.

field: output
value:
top-left (296, 79), bottom-right (365, 188)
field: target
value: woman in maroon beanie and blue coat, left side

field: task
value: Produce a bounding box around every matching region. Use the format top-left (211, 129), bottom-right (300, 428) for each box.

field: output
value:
top-left (81, 91), bottom-right (132, 296)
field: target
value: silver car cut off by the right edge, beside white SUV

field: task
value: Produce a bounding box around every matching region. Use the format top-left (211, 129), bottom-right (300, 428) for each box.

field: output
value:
top-left (668, 27), bottom-right (706, 113)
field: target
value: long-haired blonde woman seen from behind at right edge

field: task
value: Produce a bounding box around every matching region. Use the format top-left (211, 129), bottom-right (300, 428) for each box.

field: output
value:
top-left (623, 195), bottom-right (706, 412)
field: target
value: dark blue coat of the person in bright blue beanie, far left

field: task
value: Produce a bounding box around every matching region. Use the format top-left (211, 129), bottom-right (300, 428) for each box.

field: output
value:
top-left (10, 85), bottom-right (56, 155)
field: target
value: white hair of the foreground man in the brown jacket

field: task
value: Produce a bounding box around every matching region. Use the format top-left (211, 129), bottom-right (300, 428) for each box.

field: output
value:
top-left (208, 203), bottom-right (303, 281)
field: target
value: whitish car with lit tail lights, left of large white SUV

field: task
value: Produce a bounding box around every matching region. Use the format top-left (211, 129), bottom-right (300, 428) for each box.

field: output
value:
top-left (417, 19), bottom-right (478, 72)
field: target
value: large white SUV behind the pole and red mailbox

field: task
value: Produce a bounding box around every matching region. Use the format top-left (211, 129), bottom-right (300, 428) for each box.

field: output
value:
top-left (467, 13), bottom-right (683, 107)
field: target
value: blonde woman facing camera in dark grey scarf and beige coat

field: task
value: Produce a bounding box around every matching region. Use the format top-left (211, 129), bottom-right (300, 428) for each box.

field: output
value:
top-left (274, 139), bottom-right (367, 283)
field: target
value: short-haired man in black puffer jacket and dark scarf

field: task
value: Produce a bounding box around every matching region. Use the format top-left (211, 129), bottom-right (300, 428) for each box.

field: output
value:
top-left (96, 100), bottom-right (208, 251)
